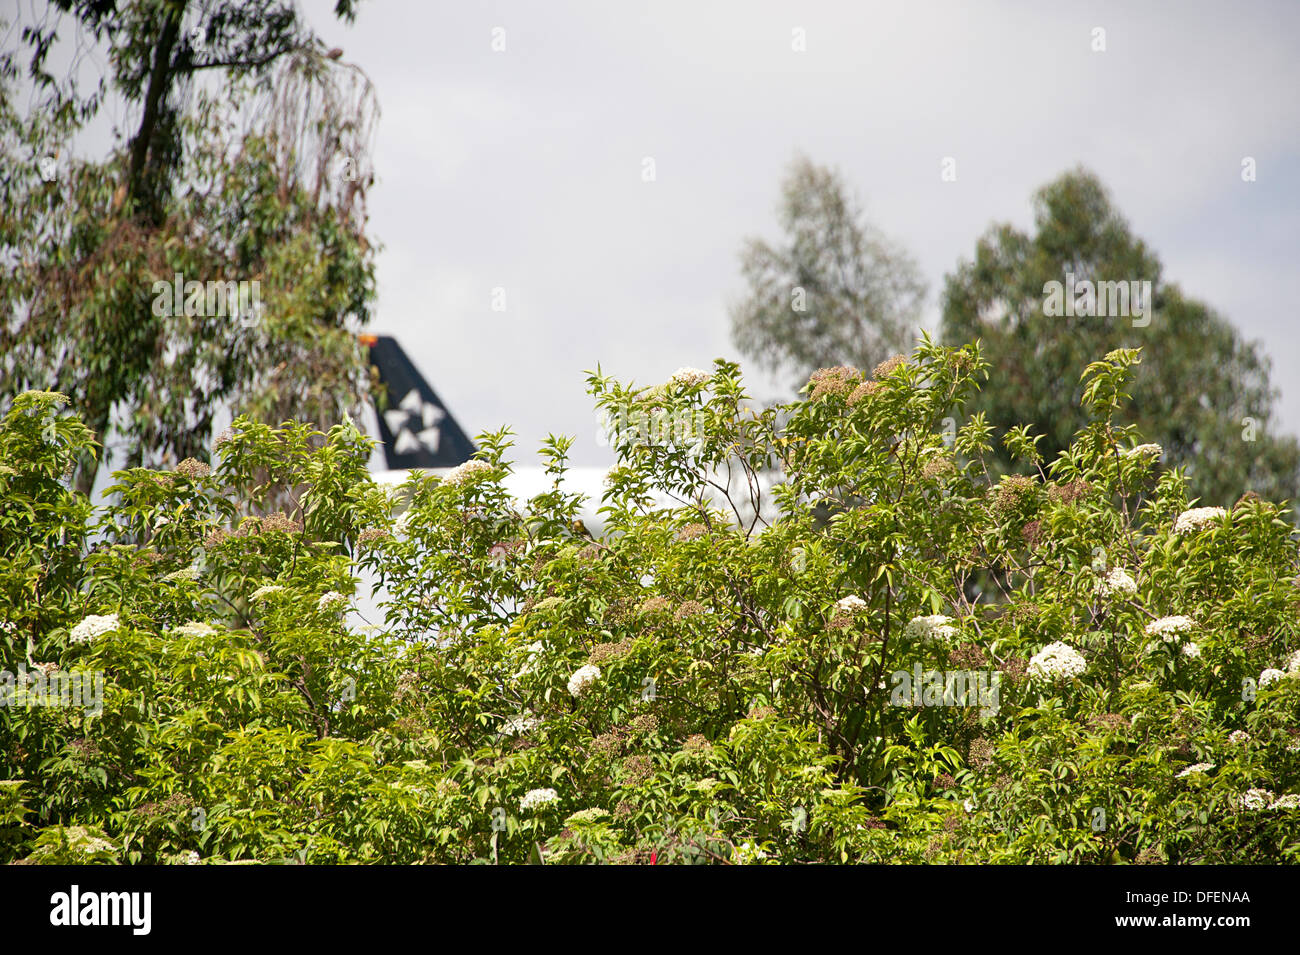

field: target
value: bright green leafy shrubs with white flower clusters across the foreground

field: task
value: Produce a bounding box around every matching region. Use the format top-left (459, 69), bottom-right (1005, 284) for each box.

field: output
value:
top-left (0, 340), bottom-right (1300, 864)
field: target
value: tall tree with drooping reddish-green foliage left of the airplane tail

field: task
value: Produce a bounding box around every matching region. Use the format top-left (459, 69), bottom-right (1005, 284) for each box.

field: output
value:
top-left (0, 0), bottom-right (378, 491)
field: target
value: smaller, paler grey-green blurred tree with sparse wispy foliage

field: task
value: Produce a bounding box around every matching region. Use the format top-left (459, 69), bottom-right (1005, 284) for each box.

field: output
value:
top-left (731, 157), bottom-right (926, 386)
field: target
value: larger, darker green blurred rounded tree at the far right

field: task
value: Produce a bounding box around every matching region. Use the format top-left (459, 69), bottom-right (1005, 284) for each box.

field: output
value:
top-left (941, 170), bottom-right (1300, 504)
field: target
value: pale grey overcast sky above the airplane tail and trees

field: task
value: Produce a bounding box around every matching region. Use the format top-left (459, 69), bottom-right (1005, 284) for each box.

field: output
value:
top-left (297, 0), bottom-right (1300, 465)
